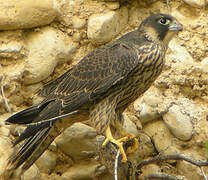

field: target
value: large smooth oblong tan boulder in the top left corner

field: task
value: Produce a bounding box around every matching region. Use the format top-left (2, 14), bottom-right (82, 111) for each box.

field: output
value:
top-left (0, 0), bottom-right (57, 30)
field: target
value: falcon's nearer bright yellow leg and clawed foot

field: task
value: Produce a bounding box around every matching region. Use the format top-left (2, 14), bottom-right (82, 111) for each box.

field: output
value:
top-left (102, 126), bottom-right (127, 162)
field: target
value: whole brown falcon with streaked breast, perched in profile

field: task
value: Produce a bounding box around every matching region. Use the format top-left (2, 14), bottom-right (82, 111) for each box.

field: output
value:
top-left (6, 14), bottom-right (182, 176)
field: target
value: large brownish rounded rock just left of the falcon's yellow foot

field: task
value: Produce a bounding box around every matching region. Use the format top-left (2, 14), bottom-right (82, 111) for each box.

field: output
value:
top-left (55, 123), bottom-right (97, 161)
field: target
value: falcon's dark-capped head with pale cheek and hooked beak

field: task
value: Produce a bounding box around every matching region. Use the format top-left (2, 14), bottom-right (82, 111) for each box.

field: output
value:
top-left (139, 14), bottom-right (183, 45)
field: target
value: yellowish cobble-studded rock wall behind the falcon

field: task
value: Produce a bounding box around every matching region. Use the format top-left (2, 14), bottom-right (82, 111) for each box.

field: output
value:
top-left (0, 0), bottom-right (208, 180)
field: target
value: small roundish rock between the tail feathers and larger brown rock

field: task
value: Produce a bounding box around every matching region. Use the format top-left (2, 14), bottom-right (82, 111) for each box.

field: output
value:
top-left (35, 150), bottom-right (57, 174)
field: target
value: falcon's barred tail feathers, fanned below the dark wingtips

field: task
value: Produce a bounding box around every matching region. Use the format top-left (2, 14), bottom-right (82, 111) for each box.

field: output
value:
top-left (8, 122), bottom-right (55, 173)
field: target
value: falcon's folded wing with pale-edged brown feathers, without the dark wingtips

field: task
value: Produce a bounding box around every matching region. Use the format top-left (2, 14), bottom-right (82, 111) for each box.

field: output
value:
top-left (40, 34), bottom-right (151, 112)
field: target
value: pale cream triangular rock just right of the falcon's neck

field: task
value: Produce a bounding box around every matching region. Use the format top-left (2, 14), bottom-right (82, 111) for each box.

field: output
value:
top-left (166, 38), bottom-right (194, 64)
